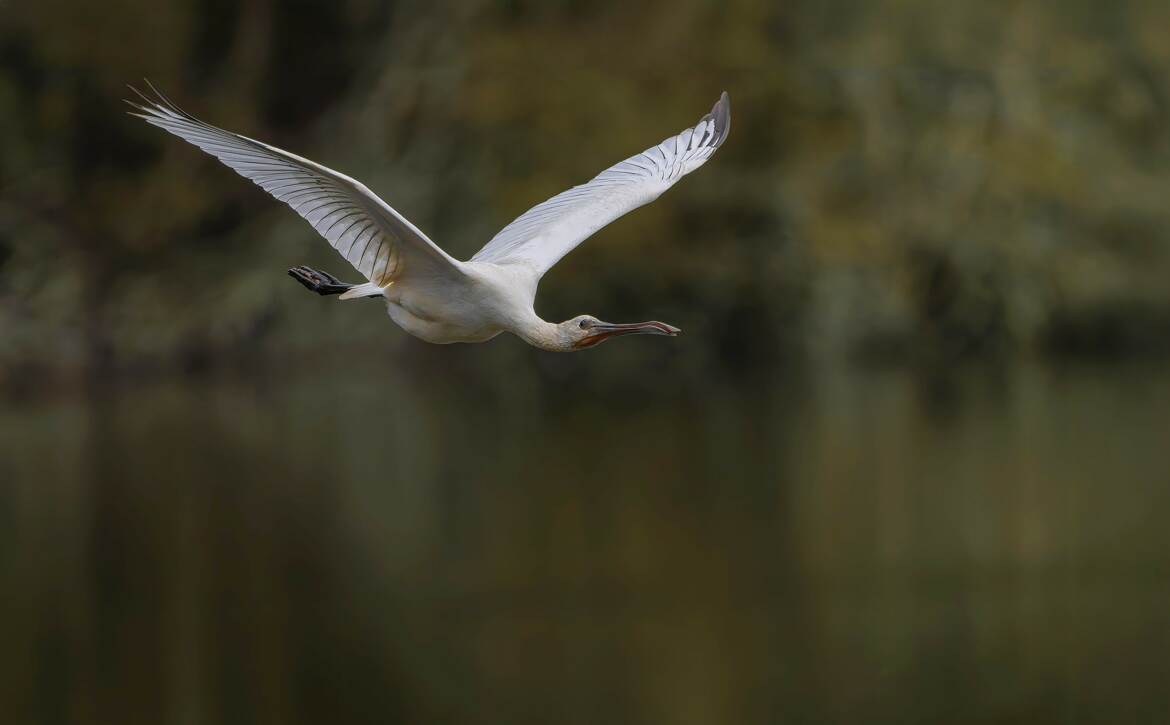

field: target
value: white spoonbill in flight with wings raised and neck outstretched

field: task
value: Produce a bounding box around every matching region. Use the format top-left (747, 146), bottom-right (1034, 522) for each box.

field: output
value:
top-left (128, 81), bottom-right (731, 352)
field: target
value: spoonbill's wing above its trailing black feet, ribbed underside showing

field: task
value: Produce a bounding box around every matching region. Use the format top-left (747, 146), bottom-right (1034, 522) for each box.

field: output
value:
top-left (128, 82), bottom-right (462, 286)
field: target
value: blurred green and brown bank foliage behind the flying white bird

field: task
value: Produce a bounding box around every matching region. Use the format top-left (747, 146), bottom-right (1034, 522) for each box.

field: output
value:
top-left (0, 0), bottom-right (1170, 390)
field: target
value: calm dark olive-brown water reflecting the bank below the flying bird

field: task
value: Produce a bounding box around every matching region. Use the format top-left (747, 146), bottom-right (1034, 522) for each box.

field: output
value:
top-left (0, 366), bottom-right (1170, 724)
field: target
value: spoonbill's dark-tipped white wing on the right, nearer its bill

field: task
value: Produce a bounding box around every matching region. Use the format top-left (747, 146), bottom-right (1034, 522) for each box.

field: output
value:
top-left (472, 92), bottom-right (731, 275)
